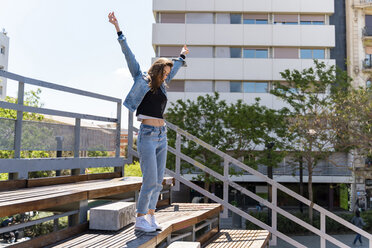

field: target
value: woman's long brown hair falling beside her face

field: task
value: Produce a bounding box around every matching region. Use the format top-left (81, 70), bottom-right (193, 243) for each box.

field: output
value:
top-left (147, 58), bottom-right (173, 92)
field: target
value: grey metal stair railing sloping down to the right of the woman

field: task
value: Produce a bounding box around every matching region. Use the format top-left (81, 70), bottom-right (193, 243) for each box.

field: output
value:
top-left (128, 112), bottom-right (372, 248)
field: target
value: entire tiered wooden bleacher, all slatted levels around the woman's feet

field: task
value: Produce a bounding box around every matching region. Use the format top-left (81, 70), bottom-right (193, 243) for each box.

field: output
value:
top-left (0, 173), bottom-right (269, 248)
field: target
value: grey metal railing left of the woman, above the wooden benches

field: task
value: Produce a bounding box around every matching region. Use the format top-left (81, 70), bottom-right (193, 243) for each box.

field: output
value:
top-left (0, 70), bottom-right (128, 179)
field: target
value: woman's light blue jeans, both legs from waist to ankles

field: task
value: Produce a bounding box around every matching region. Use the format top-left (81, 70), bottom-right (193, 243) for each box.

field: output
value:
top-left (137, 124), bottom-right (168, 214)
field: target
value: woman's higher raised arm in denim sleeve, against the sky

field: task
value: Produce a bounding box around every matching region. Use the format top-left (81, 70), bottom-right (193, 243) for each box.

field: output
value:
top-left (108, 12), bottom-right (142, 78)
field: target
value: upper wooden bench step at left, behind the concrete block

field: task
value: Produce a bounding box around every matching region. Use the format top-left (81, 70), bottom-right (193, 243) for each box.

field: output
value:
top-left (0, 177), bottom-right (174, 217)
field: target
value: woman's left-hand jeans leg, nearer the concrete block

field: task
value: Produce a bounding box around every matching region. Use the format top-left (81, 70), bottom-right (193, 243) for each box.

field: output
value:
top-left (137, 133), bottom-right (157, 216)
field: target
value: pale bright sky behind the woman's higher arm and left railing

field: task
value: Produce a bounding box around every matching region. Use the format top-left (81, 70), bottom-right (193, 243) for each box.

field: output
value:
top-left (0, 0), bottom-right (155, 129)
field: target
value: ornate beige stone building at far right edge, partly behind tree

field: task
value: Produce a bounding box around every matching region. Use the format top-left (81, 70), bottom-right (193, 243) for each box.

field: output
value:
top-left (345, 0), bottom-right (372, 207)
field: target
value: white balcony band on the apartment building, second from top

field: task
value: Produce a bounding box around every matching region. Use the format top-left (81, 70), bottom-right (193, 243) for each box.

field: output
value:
top-left (152, 23), bottom-right (335, 48)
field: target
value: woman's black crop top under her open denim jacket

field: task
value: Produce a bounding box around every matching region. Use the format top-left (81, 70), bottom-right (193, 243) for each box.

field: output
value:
top-left (136, 88), bottom-right (167, 119)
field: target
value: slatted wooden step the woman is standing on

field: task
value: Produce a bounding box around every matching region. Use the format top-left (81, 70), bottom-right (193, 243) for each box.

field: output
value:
top-left (43, 203), bottom-right (222, 248)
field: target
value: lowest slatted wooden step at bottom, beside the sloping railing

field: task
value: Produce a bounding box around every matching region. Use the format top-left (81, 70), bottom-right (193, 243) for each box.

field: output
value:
top-left (204, 229), bottom-right (270, 248)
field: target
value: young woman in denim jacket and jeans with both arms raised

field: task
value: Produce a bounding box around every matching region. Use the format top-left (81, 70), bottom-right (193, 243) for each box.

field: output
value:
top-left (108, 12), bottom-right (189, 232)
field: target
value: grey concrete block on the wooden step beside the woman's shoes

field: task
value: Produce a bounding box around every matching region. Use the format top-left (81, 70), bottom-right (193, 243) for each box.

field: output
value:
top-left (89, 201), bottom-right (136, 231)
